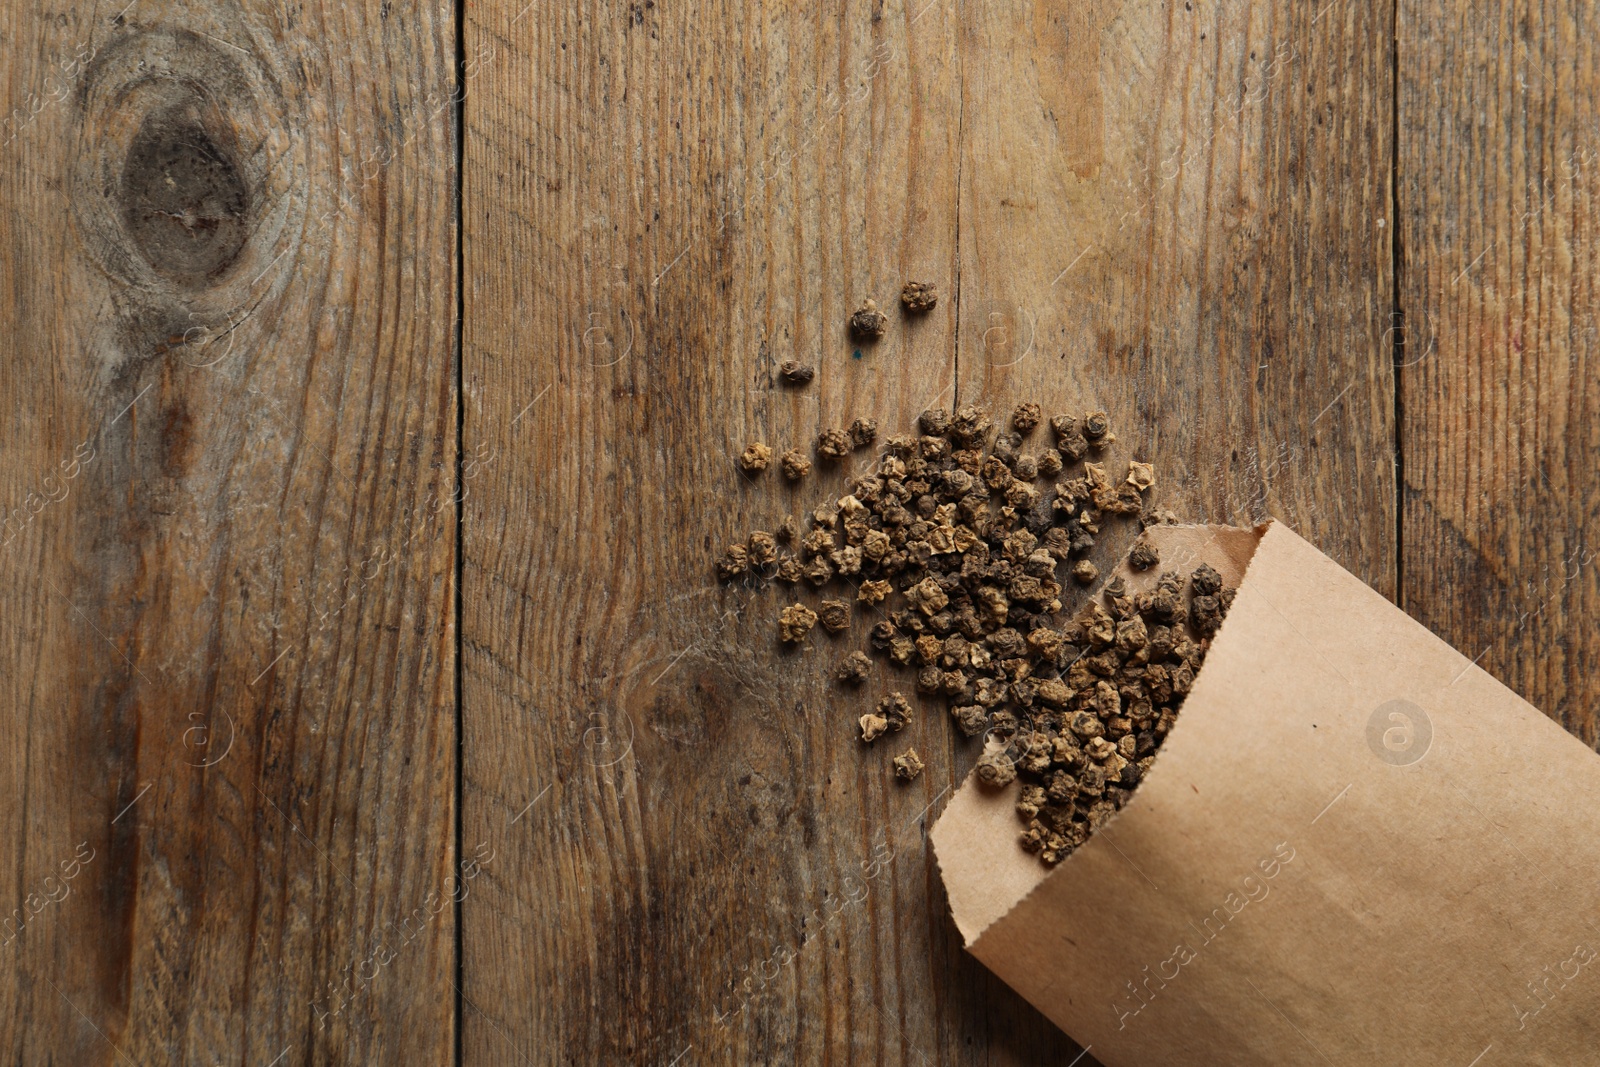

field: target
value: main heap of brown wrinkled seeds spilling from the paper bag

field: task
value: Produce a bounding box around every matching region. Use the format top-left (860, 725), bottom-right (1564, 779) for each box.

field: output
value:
top-left (717, 403), bottom-right (1232, 864)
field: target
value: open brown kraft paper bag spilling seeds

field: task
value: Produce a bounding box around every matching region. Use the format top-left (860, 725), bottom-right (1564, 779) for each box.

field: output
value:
top-left (933, 523), bottom-right (1600, 1067)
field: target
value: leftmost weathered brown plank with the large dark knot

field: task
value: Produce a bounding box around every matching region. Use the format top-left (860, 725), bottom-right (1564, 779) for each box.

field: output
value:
top-left (0, 0), bottom-right (458, 1064)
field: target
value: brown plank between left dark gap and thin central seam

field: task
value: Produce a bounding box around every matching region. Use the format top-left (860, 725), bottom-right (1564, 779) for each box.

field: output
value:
top-left (462, 2), bottom-right (972, 1062)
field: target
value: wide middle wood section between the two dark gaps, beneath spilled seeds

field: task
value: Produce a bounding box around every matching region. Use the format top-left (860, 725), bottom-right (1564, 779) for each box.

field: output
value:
top-left (462, 0), bottom-right (1395, 1064)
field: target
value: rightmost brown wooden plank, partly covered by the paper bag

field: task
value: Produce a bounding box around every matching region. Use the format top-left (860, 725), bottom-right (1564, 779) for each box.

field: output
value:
top-left (1398, 0), bottom-right (1600, 745)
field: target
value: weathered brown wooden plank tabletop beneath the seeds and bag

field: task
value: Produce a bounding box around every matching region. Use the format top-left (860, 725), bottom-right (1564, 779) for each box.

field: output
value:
top-left (0, 0), bottom-right (1600, 1067)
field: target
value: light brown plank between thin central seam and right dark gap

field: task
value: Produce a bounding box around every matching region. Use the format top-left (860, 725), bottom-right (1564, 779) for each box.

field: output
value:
top-left (928, 0), bottom-right (1395, 1062)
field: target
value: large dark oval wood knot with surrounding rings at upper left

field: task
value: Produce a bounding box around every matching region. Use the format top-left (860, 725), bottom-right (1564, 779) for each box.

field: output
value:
top-left (72, 29), bottom-right (307, 365)
